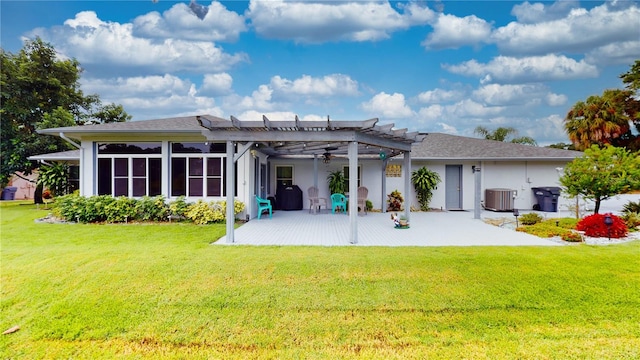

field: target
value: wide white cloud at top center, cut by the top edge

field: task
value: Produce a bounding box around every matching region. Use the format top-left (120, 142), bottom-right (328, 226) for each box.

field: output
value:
top-left (246, 0), bottom-right (433, 43)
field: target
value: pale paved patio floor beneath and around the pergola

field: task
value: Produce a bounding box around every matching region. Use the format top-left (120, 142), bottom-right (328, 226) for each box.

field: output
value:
top-left (215, 195), bottom-right (640, 246)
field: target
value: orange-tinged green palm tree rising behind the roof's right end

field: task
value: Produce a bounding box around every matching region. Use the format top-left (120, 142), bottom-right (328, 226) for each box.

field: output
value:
top-left (564, 89), bottom-right (630, 150)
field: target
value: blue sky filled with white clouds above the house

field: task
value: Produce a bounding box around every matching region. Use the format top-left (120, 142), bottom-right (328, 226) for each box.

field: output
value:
top-left (0, 0), bottom-right (640, 145)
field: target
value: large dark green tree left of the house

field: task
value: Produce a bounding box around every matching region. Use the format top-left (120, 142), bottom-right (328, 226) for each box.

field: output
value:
top-left (0, 38), bottom-right (131, 185)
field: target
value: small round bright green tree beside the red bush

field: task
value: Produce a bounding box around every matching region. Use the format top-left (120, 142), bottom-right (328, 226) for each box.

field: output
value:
top-left (560, 145), bottom-right (640, 214)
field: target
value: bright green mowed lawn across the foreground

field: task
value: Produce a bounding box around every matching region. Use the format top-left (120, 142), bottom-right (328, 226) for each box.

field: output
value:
top-left (0, 202), bottom-right (640, 359)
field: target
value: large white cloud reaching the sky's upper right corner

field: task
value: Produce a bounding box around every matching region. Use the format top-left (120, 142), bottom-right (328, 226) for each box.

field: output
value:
top-left (491, 2), bottom-right (640, 55)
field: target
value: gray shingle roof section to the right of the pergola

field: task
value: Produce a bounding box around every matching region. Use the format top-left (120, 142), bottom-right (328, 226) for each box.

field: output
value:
top-left (411, 133), bottom-right (583, 161)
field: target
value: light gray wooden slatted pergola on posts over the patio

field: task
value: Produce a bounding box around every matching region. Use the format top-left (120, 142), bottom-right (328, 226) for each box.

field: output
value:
top-left (196, 116), bottom-right (425, 244)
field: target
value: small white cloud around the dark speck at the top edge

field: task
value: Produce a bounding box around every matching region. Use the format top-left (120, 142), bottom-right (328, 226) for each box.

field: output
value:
top-left (132, 1), bottom-right (247, 41)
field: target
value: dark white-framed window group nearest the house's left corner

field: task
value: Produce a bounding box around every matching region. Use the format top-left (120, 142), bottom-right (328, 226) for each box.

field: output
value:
top-left (97, 143), bottom-right (162, 197)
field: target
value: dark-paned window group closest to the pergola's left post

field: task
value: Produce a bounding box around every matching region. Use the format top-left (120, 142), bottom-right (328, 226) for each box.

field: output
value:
top-left (171, 143), bottom-right (227, 197)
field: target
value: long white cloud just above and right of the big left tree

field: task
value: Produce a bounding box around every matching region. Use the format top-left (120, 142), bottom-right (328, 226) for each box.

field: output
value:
top-left (26, 11), bottom-right (247, 75)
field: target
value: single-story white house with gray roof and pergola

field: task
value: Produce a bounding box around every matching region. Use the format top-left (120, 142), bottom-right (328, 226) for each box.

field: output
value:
top-left (31, 115), bottom-right (581, 242)
